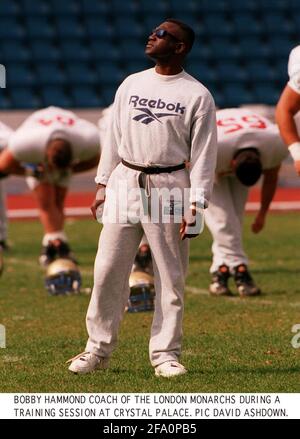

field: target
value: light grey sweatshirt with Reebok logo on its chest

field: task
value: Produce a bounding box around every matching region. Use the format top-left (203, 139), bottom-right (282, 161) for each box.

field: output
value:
top-left (95, 68), bottom-right (217, 205)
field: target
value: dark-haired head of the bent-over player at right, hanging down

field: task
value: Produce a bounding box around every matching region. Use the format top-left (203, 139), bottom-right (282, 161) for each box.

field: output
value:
top-left (234, 147), bottom-right (262, 186)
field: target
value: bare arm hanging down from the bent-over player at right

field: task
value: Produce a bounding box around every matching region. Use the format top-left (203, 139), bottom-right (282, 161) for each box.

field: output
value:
top-left (252, 166), bottom-right (280, 233)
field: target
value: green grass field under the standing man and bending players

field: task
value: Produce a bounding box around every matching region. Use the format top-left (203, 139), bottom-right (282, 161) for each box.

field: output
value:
top-left (0, 213), bottom-right (300, 393)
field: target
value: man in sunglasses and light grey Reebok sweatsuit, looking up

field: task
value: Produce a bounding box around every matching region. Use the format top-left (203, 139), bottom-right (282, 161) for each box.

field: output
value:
top-left (69, 19), bottom-right (217, 377)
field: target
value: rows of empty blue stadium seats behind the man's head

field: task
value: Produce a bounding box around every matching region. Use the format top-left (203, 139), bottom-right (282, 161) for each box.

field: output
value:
top-left (0, 0), bottom-right (300, 109)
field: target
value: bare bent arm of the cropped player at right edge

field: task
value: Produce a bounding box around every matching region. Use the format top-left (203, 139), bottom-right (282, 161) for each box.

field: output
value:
top-left (275, 85), bottom-right (300, 174)
